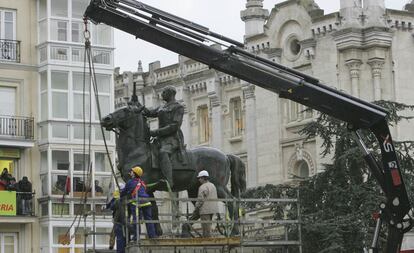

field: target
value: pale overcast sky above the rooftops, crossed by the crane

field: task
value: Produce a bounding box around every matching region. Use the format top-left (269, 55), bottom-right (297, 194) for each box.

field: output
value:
top-left (114, 0), bottom-right (410, 72)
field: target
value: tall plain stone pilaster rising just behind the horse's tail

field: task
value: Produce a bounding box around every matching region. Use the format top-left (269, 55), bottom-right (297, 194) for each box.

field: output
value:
top-left (242, 81), bottom-right (258, 187)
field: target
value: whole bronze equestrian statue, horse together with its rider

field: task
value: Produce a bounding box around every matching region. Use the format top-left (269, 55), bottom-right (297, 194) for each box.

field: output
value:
top-left (101, 86), bottom-right (246, 235)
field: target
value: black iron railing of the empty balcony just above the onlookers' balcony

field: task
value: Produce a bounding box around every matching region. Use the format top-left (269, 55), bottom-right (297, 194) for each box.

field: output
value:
top-left (0, 115), bottom-right (34, 140)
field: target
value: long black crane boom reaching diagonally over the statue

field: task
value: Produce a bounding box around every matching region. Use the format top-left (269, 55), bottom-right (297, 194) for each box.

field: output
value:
top-left (85, 0), bottom-right (412, 253)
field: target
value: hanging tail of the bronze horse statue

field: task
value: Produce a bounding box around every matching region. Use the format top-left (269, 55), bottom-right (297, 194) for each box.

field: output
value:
top-left (227, 155), bottom-right (246, 197)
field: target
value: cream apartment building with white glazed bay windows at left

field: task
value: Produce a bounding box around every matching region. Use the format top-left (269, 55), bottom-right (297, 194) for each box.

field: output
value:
top-left (0, 0), bottom-right (115, 253)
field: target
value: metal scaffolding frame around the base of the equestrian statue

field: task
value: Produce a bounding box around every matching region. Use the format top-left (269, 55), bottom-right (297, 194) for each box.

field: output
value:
top-left (85, 191), bottom-right (302, 253)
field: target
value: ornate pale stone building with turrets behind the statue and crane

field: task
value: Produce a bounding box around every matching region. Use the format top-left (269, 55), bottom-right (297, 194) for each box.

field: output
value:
top-left (115, 0), bottom-right (414, 190)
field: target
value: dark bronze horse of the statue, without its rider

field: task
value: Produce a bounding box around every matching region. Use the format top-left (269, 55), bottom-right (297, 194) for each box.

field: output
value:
top-left (101, 103), bottom-right (246, 235)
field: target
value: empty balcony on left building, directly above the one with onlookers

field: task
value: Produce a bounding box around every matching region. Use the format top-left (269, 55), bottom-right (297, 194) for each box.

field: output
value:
top-left (0, 115), bottom-right (34, 147)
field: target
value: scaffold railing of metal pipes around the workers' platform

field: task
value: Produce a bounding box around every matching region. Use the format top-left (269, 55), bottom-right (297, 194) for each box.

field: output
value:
top-left (85, 192), bottom-right (302, 253)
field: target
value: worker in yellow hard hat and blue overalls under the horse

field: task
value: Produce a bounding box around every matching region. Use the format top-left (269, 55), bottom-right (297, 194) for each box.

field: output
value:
top-left (121, 166), bottom-right (156, 241)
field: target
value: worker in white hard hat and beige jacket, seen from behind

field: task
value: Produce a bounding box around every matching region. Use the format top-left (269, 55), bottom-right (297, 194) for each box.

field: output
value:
top-left (190, 170), bottom-right (219, 237)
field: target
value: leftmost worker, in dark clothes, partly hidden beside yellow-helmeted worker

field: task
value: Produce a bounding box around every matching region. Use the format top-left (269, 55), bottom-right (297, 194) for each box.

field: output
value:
top-left (106, 183), bottom-right (126, 253)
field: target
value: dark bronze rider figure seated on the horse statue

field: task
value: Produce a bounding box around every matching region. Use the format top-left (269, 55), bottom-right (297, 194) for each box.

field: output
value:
top-left (143, 86), bottom-right (184, 188)
